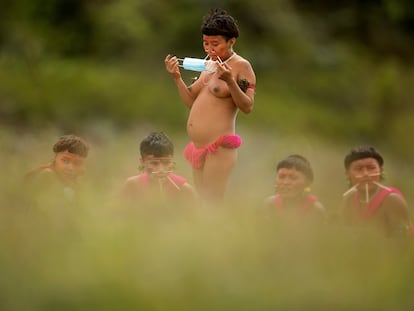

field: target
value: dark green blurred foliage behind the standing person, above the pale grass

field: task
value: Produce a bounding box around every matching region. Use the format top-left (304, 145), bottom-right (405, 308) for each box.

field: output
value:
top-left (0, 0), bottom-right (414, 151)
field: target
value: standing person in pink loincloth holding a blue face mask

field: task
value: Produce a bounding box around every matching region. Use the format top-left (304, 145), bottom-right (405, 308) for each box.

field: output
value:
top-left (165, 9), bottom-right (256, 203)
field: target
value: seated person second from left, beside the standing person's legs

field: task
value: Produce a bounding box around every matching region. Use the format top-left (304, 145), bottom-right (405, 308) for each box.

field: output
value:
top-left (121, 132), bottom-right (196, 205)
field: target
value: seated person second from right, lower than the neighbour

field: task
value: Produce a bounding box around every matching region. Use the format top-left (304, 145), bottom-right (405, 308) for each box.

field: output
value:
top-left (265, 154), bottom-right (325, 220)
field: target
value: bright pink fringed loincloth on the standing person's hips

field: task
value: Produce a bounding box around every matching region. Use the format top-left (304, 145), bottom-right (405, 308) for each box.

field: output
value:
top-left (184, 135), bottom-right (242, 168)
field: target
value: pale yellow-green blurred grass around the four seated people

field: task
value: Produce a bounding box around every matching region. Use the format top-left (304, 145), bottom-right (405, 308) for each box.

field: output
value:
top-left (0, 128), bottom-right (414, 310)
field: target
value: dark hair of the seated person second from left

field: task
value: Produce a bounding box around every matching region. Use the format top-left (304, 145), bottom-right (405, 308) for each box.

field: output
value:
top-left (140, 132), bottom-right (174, 158)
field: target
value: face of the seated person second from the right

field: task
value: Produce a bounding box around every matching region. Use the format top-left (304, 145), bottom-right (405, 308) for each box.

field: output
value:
top-left (276, 168), bottom-right (310, 198)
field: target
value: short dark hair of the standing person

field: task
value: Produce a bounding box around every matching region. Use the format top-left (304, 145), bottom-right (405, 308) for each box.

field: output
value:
top-left (201, 9), bottom-right (239, 40)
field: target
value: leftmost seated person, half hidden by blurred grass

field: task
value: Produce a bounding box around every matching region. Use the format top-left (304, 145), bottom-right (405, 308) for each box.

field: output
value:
top-left (25, 134), bottom-right (89, 204)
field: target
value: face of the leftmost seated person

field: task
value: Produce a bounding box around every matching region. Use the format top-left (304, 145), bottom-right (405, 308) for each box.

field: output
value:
top-left (54, 150), bottom-right (86, 184)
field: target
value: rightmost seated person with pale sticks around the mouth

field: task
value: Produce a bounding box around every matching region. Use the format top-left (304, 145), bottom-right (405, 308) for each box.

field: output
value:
top-left (341, 146), bottom-right (413, 236)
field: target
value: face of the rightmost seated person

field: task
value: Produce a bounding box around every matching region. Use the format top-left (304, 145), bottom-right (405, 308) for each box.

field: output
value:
top-left (347, 158), bottom-right (382, 190)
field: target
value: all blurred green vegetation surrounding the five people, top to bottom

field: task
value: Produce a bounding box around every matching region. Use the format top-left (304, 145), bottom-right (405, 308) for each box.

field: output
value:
top-left (0, 0), bottom-right (414, 310)
